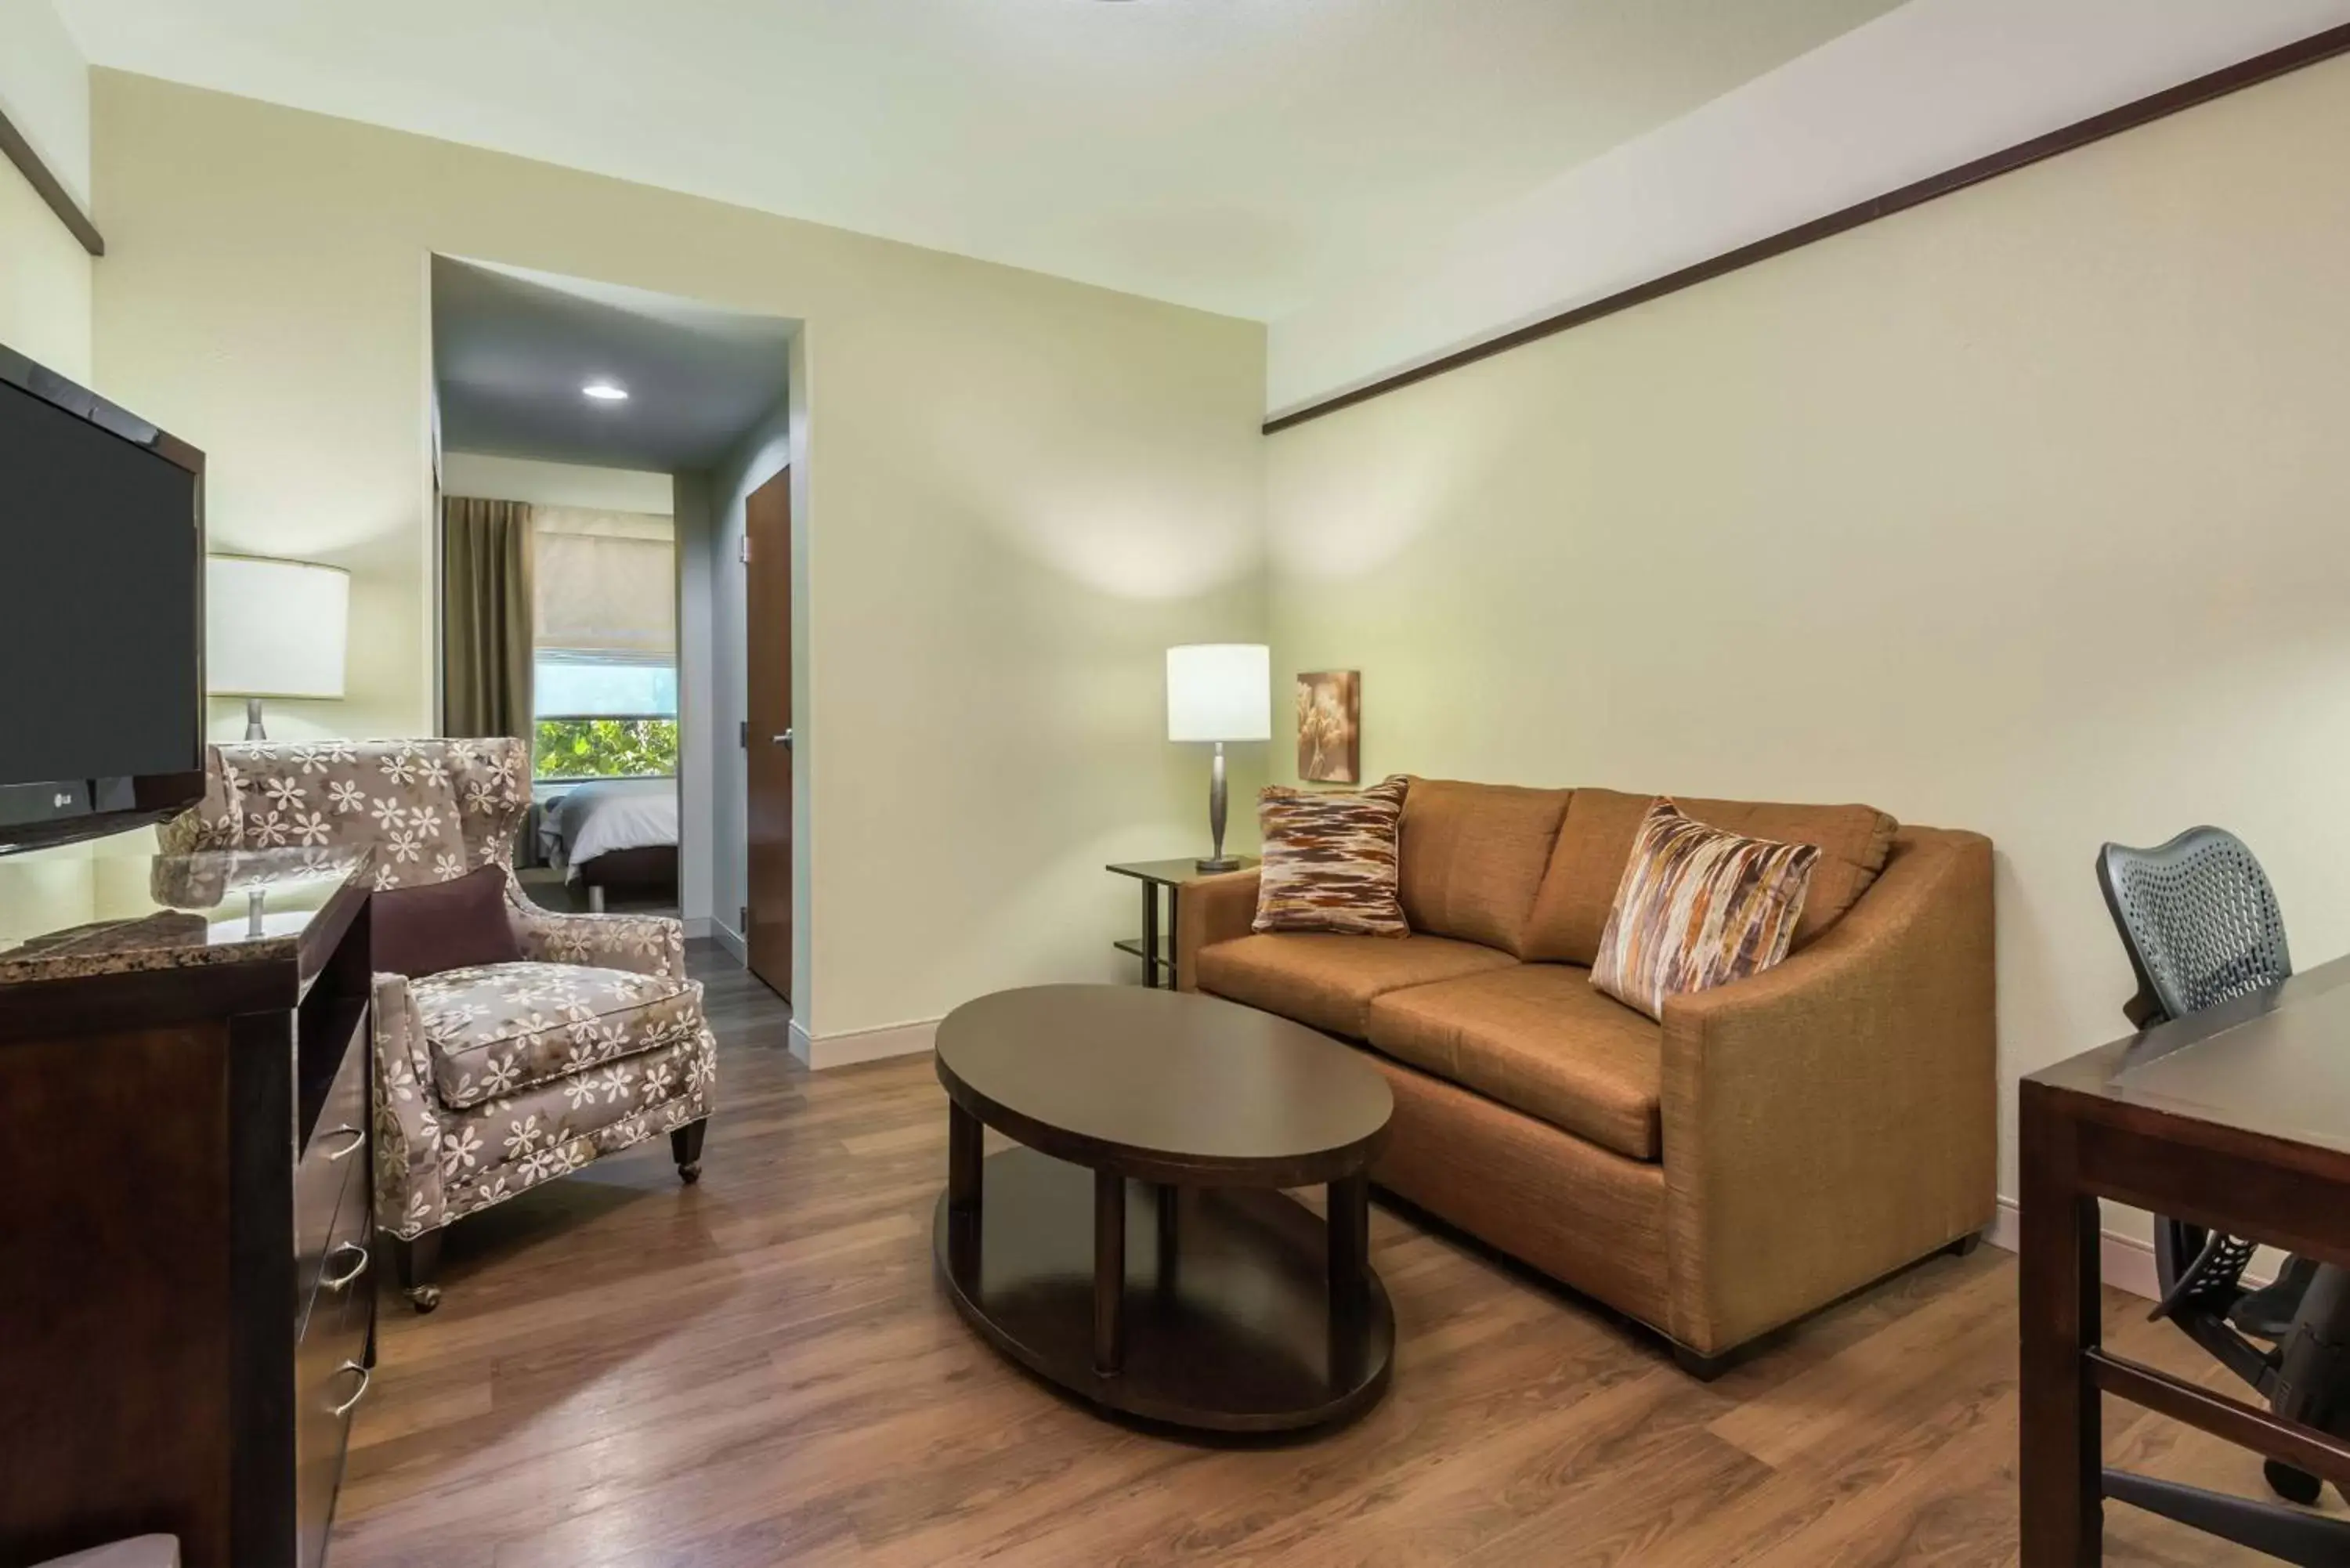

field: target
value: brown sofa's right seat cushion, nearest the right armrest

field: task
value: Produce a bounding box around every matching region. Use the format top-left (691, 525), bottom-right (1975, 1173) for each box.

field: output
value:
top-left (1370, 964), bottom-right (1664, 1159)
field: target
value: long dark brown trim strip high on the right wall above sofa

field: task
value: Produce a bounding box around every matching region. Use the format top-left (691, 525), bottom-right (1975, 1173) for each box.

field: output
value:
top-left (1264, 23), bottom-right (2350, 435)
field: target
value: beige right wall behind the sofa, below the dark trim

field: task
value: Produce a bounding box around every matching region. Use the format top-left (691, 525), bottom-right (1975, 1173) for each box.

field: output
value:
top-left (1267, 61), bottom-right (2350, 1194)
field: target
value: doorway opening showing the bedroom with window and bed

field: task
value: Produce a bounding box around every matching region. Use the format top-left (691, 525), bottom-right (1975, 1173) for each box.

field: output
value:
top-left (432, 256), bottom-right (799, 999)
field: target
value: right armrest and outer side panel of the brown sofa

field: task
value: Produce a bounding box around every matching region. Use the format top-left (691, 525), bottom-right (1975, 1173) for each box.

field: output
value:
top-left (1661, 828), bottom-right (2000, 1354)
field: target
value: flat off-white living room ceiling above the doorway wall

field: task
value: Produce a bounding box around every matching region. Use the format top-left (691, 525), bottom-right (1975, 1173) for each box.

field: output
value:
top-left (59, 0), bottom-right (1894, 320)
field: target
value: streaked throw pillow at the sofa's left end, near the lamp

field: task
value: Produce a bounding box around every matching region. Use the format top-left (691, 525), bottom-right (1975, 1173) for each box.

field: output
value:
top-left (1255, 775), bottom-right (1412, 936)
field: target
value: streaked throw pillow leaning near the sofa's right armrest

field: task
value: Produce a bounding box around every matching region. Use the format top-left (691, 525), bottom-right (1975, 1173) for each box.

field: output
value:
top-left (1591, 800), bottom-right (1819, 1021)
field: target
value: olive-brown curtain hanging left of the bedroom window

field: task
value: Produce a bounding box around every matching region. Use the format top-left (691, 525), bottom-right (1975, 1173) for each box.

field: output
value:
top-left (442, 496), bottom-right (531, 740)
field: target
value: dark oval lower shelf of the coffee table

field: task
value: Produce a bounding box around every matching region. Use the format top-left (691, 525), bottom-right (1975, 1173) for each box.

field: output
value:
top-left (933, 1147), bottom-right (1396, 1432)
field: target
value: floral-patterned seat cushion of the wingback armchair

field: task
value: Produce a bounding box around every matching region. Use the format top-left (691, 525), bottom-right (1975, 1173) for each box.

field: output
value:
top-left (414, 964), bottom-right (703, 1110)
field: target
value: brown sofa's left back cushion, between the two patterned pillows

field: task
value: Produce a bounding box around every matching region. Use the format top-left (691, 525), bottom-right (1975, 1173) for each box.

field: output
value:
top-left (1398, 778), bottom-right (1567, 957)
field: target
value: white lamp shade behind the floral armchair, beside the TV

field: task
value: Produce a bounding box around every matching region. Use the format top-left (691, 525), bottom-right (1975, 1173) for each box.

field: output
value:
top-left (204, 555), bottom-right (350, 695)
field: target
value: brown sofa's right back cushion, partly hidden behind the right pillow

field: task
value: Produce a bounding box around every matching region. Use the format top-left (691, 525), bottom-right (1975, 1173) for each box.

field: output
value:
top-left (1518, 790), bottom-right (1899, 964)
